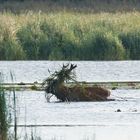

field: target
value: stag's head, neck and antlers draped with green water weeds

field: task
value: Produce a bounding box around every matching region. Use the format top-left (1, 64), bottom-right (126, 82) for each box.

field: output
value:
top-left (43, 64), bottom-right (77, 101)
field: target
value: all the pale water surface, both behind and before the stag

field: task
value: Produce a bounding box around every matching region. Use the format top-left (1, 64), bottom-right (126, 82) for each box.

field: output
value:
top-left (0, 61), bottom-right (140, 140)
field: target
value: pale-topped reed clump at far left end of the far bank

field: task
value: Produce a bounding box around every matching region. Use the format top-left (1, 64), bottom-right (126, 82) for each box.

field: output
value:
top-left (0, 20), bottom-right (24, 60)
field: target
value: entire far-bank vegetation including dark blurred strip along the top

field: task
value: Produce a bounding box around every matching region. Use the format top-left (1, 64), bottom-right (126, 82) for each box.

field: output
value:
top-left (0, 0), bottom-right (140, 60)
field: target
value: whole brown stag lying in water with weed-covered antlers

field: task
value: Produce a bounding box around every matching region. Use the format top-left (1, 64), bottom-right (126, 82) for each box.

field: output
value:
top-left (43, 64), bottom-right (110, 102)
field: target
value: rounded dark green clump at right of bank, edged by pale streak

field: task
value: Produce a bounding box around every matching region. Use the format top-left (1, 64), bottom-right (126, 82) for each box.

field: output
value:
top-left (85, 32), bottom-right (124, 60)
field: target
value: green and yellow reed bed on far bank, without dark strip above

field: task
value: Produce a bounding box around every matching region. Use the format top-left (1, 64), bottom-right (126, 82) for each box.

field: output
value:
top-left (0, 11), bottom-right (140, 60)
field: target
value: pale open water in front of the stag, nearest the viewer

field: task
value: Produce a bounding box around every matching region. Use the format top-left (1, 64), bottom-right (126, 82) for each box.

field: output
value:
top-left (17, 90), bottom-right (140, 140)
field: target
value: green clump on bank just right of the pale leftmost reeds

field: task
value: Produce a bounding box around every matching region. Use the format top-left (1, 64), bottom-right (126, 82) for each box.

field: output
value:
top-left (17, 23), bottom-right (46, 60)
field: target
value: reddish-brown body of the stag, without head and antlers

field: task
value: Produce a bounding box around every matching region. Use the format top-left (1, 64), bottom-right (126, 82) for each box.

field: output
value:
top-left (58, 86), bottom-right (110, 101)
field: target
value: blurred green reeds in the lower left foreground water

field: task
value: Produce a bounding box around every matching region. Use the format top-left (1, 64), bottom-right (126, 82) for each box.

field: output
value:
top-left (0, 73), bottom-right (41, 140)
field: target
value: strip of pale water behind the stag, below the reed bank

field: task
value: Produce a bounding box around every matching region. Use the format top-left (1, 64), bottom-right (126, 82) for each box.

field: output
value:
top-left (0, 61), bottom-right (140, 83)
